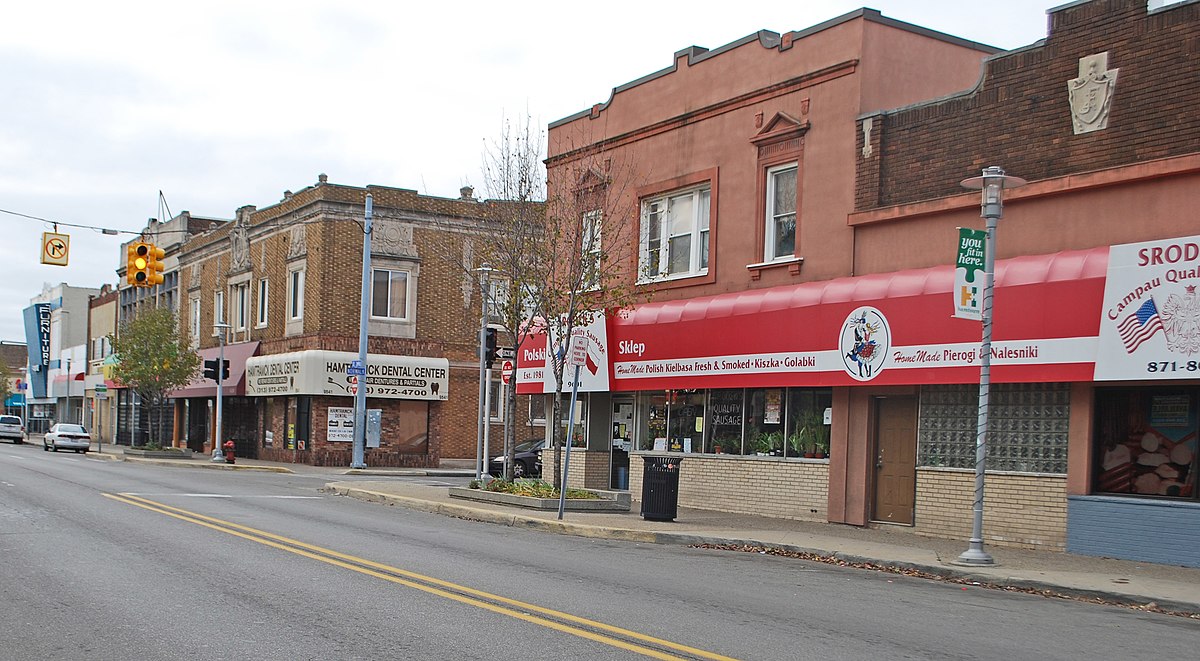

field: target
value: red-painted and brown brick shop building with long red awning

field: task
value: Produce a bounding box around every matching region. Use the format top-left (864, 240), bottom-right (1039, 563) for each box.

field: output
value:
top-left (518, 0), bottom-right (1200, 566)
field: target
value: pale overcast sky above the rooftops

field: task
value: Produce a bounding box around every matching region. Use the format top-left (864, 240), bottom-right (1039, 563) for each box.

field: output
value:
top-left (0, 0), bottom-right (1061, 342)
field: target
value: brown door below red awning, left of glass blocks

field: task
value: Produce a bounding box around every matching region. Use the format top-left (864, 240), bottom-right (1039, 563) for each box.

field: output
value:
top-left (874, 396), bottom-right (917, 525)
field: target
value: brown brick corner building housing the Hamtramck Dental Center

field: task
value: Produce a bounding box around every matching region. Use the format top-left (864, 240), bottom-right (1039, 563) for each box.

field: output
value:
top-left (173, 175), bottom-right (524, 467)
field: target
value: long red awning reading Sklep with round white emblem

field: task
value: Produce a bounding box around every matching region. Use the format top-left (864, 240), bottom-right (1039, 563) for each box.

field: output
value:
top-left (604, 246), bottom-right (1109, 391)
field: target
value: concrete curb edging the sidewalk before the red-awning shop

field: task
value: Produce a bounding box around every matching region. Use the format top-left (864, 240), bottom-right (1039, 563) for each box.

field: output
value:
top-left (322, 483), bottom-right (1200, 614)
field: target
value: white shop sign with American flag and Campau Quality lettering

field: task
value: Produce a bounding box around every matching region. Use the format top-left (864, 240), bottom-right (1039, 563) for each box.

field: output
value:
top-left (1096, 236), bottom-right (1200, 380)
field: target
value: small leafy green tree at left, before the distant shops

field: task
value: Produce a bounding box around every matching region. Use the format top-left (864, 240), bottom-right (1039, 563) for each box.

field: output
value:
top-left (108, 308), bottom-right (200, 444)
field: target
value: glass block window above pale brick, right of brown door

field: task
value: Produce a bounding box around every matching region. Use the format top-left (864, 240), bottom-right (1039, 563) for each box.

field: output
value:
top-left (917, 384), bottom-right (1070, 474)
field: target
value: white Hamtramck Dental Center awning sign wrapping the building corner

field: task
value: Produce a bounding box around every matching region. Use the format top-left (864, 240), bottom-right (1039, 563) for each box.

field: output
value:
top-left (246, 350), bottom-right (450, 401)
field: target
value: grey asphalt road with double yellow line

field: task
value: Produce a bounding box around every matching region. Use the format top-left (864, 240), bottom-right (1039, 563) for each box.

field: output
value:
top-left (0, 445), bottom-right (1200, 661)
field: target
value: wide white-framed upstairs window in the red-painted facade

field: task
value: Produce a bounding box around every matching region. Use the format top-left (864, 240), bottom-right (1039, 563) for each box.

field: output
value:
top-left (638, 185), bottom-right (712, 282)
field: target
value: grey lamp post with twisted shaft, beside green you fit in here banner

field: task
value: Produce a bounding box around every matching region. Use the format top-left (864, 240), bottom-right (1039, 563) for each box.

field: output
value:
top-left (958, 166), bottom-right (1025, 565)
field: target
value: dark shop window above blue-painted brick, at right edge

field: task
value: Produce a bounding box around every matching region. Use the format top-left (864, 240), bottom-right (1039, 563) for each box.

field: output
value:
top-left (1092, 387), bottom-right (1200, 499)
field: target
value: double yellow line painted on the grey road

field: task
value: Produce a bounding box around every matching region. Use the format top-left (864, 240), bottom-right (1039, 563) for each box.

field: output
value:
top-left (104, 493), bottom-right (733, 661)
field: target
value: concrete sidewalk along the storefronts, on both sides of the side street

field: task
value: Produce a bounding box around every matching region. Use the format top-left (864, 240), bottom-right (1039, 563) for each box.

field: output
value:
top-left (92, 446), bottom-right (1200, 619)
